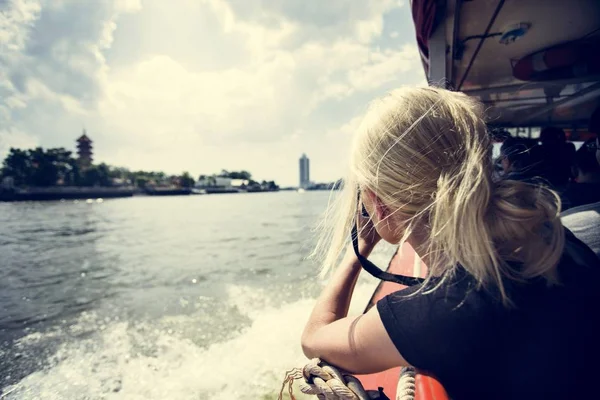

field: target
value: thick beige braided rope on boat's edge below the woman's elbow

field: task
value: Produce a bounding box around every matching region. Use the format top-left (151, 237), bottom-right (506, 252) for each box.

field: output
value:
top-left (278, 358), bottom-right (415, 400)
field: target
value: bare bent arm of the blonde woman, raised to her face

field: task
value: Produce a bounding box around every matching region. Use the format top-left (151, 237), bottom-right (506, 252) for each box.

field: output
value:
top-left (302, 240), bottom-right (408, 373)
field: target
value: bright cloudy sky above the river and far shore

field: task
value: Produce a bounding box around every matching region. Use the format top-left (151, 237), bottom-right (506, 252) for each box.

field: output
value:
top-left (0, 0), bottom-right (425, 185)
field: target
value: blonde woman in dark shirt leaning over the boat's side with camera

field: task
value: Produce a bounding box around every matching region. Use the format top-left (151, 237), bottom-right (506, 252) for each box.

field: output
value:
top-left (302, 88), bottom-right (600, 399)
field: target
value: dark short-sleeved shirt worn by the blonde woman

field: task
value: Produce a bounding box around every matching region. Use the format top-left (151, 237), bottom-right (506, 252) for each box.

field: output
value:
top-left (377, 234), bottom-right (600, 400)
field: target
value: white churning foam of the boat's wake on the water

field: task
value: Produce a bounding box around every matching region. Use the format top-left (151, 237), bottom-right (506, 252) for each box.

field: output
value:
top-left (4, 284), bottom-right (373, 400)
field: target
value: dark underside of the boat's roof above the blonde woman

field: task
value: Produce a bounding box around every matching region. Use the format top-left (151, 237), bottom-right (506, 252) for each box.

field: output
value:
top-left (411, 0), bottom-right (600, 128)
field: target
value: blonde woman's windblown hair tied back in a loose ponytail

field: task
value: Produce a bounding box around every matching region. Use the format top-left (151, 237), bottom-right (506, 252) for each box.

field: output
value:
top-left (314, 87), bottom-right (565, 304)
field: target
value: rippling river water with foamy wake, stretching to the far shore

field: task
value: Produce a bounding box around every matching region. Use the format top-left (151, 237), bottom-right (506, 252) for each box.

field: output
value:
top-left (0, 192), bottom-right (393, 400)
